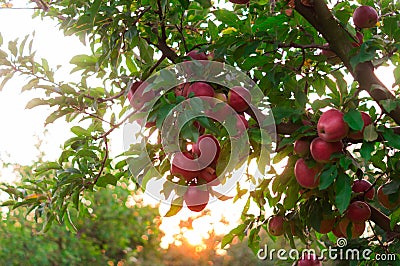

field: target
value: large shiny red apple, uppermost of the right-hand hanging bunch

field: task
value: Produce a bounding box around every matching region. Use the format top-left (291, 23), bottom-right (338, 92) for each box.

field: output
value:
top-left (317, 109), bottom-right (349, 142)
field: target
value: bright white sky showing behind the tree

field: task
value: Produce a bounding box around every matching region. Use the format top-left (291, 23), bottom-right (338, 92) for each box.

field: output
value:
top-left (0, 1), bottom-right (394, 247)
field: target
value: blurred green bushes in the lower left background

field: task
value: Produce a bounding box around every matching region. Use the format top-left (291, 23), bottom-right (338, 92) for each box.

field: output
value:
top-left (0, 178), bottom-right (161, 265)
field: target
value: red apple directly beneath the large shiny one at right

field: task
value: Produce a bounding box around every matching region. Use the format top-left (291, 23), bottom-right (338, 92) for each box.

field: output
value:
top-left (310, 138), bottom-right (343, 163)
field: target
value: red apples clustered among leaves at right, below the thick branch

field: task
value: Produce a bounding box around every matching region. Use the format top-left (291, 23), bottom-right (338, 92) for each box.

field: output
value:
top-left (268, 109), bottom-right (400, 243)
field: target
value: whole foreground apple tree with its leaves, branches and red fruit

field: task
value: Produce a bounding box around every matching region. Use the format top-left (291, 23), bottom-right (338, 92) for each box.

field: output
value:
top-left (0, 0), bottom-right (400, 265)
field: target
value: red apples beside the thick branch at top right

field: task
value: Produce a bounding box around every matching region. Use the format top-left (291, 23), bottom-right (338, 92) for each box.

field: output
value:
top-left (321, 6), bottom-right (379, 64)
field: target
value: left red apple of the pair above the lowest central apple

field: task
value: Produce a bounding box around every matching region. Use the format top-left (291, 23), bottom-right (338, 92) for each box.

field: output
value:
top-left (170, 152), bottom-right (200, 182)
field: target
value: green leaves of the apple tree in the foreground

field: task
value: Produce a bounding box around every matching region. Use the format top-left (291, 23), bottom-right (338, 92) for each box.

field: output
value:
top-left (0, 0), bottom-right (400, 264)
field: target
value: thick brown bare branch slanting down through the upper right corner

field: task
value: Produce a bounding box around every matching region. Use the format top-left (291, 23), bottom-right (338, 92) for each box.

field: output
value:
top-left (295, 0), bottom-right (400, 125)
